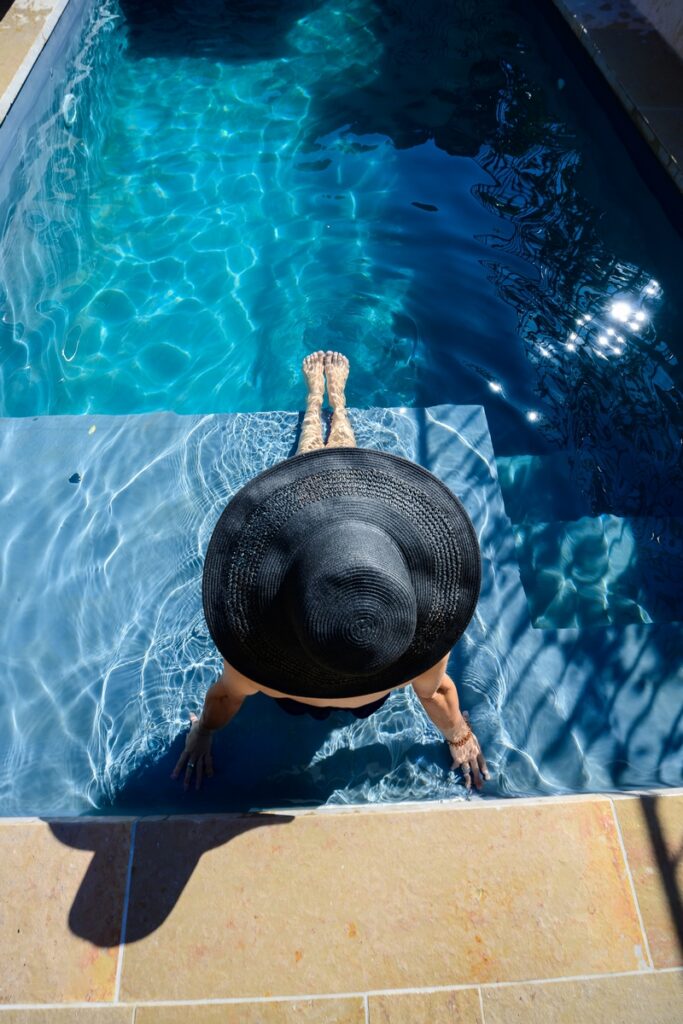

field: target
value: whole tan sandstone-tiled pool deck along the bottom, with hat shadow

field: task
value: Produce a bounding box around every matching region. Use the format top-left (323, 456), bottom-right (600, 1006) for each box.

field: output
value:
top-left (0, 790), bottom-right (683, 1011)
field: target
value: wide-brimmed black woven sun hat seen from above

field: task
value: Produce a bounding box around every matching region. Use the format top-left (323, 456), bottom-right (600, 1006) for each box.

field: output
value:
top-left (202, 449), bottom-right (481, 698)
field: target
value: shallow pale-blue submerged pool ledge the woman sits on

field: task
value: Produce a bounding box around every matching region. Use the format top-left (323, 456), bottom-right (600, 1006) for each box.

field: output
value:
top-left (0, 406), bottom-right (683, 816)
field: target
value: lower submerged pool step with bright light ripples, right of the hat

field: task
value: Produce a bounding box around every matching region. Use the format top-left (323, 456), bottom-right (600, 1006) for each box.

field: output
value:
top-left (514, 515), bottom-right (683, 629)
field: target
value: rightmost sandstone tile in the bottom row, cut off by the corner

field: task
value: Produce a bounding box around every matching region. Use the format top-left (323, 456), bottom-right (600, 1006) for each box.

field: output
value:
top-left (482, 972), bottom-right (683, 1024)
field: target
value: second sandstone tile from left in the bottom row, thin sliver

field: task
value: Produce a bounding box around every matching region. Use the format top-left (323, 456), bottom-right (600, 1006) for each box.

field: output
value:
top-left (135, 996), bottom-right (366, 1024)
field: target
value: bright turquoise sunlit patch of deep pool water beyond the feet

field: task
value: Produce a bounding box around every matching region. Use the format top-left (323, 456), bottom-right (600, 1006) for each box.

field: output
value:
top-left (0, 0), bottom-right (417, 416)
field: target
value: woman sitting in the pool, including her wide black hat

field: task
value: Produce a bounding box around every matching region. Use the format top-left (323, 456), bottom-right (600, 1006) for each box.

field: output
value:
top-left (172, 352), bottom-right (489, 790)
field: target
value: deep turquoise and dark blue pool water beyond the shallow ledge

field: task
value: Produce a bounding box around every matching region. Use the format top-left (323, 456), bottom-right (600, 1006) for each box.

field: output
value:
top-left (0, 0), bottom-right (683, 806)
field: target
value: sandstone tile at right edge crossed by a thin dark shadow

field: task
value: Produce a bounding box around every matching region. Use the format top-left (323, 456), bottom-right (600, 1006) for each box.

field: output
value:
top-left (614, 796), bottom-right (683, 966)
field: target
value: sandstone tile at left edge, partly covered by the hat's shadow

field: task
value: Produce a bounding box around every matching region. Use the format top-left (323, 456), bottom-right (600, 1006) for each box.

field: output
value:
top-left (0, 821), bottom-right (130, 1003)
